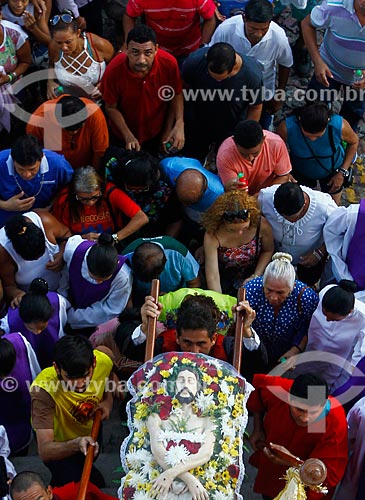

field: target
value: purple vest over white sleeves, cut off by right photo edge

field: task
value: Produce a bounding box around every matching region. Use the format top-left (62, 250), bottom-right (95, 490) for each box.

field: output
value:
top-left (346, 199), bottom-right (365, 290)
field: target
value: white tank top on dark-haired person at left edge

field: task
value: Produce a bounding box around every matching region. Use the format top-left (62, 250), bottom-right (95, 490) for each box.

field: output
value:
top-left (0, 212), bottom-right (61, 292)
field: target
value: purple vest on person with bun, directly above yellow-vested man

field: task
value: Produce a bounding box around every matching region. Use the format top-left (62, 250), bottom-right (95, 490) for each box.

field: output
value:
top-left (8, 292), bottom-right (60, 370)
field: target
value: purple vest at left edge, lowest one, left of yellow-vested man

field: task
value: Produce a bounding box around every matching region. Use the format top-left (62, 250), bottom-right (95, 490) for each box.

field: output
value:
top-left (0, 333), bottom-right (32, 453)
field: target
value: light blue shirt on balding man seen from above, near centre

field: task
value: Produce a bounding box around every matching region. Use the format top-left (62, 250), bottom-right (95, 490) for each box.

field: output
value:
top-left (160, 156), bottom-right (224, 222)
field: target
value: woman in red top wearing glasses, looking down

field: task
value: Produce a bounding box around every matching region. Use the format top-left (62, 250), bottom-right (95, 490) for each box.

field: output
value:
top-left (52, 166), bottom-right (148, 243)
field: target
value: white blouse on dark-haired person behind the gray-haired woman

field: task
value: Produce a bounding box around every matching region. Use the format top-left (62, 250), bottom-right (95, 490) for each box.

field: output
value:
top-left (258, 184), bottom-right (338, 265)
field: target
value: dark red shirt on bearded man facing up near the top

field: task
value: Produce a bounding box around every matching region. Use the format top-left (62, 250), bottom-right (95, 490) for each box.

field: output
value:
top-left (100, 49), bottom-right (182, 143)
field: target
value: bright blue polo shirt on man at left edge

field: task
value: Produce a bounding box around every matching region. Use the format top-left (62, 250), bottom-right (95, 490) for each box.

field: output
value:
top-left (0, 149), bottom-right (74, 227)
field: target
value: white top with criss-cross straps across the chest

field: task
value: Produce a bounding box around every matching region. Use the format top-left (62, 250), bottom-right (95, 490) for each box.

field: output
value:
top-left (54, 34), bottom-right (106, 96)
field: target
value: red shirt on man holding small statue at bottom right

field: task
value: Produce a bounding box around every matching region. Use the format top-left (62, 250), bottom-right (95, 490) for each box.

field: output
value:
top-left (247, 375), bottom-right (347, 500)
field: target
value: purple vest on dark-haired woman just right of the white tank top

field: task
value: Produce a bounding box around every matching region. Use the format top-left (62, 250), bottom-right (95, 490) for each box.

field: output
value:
top-left (69, 240), bottom-right (127, 309)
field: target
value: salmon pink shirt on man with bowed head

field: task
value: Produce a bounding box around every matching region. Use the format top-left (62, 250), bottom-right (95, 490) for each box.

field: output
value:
top-left (217, 130), bottom-right (292, 195)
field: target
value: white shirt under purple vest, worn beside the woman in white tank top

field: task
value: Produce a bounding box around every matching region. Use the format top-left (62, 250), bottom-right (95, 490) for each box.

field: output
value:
top-left (58, 235), bottom-right (132, 328)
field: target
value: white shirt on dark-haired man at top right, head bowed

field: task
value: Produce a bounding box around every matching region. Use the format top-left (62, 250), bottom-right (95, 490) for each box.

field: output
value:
top-left (209, 16), bottom-right (293, 96)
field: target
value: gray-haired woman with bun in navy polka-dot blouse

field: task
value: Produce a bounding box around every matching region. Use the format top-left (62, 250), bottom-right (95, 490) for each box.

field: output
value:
top-left (245, 252), bottom-right (318, 368)
